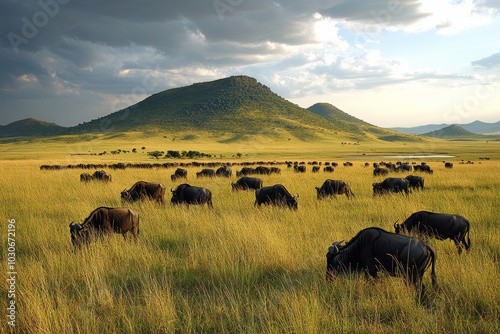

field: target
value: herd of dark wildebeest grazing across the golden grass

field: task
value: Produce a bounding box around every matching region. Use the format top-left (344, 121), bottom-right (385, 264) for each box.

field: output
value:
top-left (65, 159), bottom-right (470, 300)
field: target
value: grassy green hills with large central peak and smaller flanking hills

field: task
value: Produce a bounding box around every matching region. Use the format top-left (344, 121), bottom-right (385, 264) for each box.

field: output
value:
top-left (0, 76), bottom-right (414, 141)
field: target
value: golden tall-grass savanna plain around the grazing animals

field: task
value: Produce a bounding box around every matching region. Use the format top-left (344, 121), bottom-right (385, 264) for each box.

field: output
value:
top-left (0, 139), bottom-right (500, 333)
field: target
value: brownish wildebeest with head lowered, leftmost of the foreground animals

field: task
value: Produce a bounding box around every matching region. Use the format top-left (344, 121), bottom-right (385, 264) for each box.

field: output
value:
top-left (69, 207), bottom-right (139, 248)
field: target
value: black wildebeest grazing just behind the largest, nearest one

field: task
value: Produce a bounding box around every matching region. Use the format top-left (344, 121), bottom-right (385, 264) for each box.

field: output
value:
top-left (394, 211), bottom-right (470, 254)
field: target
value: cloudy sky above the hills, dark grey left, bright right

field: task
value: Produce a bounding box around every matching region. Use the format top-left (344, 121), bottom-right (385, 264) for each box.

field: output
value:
top-left (0, 0), bottom-right (500, 127)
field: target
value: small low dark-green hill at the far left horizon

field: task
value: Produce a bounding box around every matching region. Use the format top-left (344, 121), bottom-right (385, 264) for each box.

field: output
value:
top-left (0, 118), bottom-right (66, 137)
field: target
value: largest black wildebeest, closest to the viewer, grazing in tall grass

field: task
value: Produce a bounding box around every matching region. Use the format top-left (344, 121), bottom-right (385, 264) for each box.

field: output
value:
top-left (326, 227), bottom-right (437, 296)
